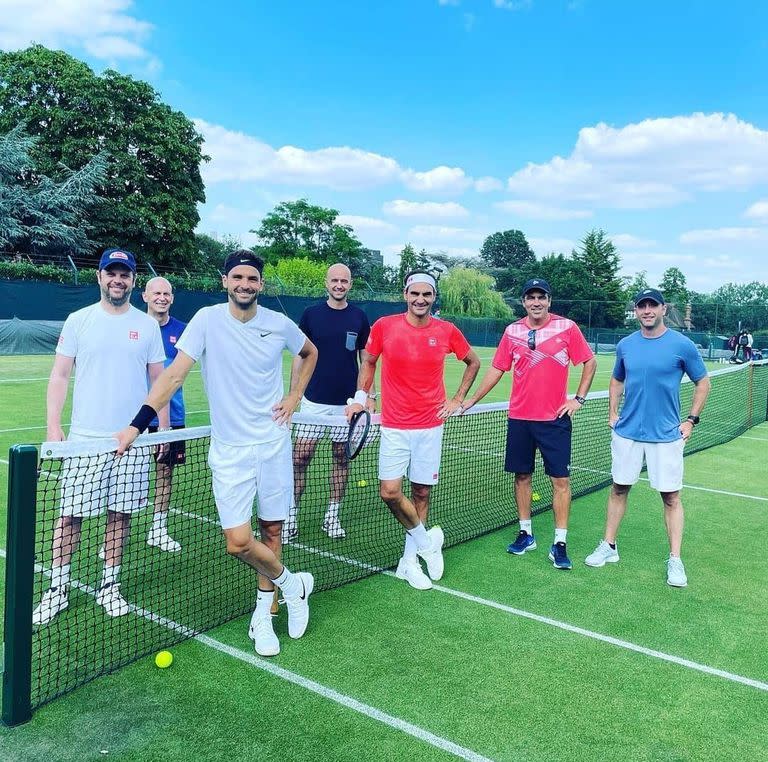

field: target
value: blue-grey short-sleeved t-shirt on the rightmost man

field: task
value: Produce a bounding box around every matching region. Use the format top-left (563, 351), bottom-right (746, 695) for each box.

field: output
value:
top-left (613, 329), bottom-right (707, 442)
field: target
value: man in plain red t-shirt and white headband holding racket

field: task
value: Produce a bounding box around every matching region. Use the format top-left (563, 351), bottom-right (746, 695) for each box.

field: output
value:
top-left (346, 272), bottom-right (480, 590)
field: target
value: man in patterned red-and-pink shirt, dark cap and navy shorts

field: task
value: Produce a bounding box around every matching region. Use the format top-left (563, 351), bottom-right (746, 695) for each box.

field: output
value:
top-left (462, 278), bottom-right (597, 569)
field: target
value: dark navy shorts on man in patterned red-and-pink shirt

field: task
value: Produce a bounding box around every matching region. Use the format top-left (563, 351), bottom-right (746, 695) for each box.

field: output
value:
top-left (504, 415), bottom-right (571, 478)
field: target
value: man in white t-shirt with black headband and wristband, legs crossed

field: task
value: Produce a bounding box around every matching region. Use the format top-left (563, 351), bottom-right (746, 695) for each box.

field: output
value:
top-left (117, 249), bottom-right (317, 656)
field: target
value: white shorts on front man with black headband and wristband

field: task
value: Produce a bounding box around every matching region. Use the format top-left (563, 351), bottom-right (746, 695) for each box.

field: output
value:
top-left (208, 437), bottom-right (293, 529)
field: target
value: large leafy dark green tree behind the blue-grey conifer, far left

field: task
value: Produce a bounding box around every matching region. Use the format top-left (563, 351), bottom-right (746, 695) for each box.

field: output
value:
top-left (0, 45), bottom-right (207, 265)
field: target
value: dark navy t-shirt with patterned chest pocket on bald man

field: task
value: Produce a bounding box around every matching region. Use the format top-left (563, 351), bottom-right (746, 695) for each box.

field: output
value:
top-left (299, 302), bottom-right (371, 405)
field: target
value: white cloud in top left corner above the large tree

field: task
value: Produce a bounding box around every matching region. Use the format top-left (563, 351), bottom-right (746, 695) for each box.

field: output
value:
top-left (0, 0), bottom-right (158, 66)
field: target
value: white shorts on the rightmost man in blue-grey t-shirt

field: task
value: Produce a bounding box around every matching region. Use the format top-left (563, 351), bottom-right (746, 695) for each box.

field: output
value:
top-left (611, 431), bottom-right (685, 492)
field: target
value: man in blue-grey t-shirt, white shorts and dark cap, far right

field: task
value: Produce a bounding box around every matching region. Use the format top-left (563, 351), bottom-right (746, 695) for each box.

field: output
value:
top-left (585, 288), bottom-right (710, 587)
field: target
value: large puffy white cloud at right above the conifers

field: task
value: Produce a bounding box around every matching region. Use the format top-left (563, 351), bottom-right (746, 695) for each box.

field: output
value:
top-left (507, 113), bottom-right (768, 208)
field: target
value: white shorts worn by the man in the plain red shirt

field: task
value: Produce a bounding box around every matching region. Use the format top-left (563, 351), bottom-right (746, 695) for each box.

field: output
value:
top-left (379, 426), bottom-right (444, 484)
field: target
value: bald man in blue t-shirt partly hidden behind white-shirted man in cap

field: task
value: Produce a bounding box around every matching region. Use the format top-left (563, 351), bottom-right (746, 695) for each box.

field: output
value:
top-left (142, 278), bottom-right (187, 553)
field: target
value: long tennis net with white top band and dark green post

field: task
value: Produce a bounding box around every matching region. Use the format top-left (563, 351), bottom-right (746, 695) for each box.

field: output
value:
top-left (3, 363), bottom-right (768, 724)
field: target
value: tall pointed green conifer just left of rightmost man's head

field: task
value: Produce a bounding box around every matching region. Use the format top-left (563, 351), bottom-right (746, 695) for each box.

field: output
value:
top-left (571, 230), bottom-right (625, 328)
